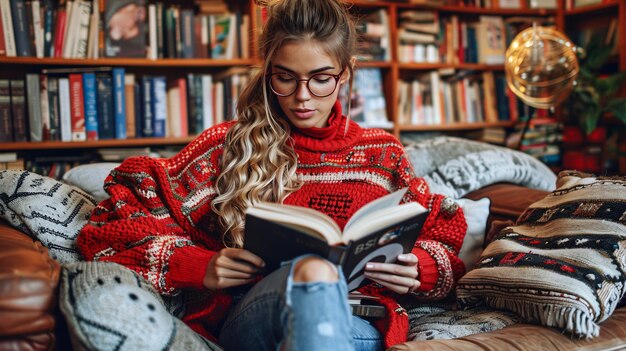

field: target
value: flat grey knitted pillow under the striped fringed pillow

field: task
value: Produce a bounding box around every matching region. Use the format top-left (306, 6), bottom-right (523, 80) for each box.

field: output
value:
top-left (407, 303), bottom-right (521, 340)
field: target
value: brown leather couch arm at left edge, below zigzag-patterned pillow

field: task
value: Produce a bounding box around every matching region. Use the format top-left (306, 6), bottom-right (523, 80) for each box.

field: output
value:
top-left (0, 223), bottom-right (60, 350)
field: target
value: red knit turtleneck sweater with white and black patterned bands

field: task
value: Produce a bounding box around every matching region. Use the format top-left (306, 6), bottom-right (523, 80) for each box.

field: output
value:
top-left (78, 104), bottom-right (467, 346)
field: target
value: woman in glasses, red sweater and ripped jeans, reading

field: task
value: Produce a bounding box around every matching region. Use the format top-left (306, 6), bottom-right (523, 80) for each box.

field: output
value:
top-left (79, 0), bottom-right (466, 350)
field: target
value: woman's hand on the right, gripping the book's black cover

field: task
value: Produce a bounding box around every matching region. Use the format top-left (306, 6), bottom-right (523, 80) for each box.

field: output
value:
top-left (365, 253), bottom-right (421, 294)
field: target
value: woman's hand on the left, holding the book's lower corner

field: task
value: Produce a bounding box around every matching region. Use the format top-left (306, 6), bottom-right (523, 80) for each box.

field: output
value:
top-left (203, 248), bottom-right (265, 290)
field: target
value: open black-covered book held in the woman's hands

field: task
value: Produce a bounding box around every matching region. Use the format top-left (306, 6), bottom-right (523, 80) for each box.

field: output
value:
top-left (243, 188), bottom-right (428, 290)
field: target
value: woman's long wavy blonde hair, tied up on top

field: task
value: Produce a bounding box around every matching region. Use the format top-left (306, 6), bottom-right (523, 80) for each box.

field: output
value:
top-left (212, 0), bottom-right (356, 247)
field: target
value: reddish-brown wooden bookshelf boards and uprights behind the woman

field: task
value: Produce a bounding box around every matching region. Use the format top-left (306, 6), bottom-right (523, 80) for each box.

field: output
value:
top-left (0, 0), bottom-right (626, 176)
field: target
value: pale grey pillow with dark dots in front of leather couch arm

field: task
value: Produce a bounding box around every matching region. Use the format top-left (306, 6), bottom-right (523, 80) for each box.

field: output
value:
top-left (60, 262), bottom-right (221, 351)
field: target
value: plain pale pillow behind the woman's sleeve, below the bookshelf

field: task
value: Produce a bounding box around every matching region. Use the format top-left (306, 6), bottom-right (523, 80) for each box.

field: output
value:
top-left (63, 162), bottom-right (120, 202)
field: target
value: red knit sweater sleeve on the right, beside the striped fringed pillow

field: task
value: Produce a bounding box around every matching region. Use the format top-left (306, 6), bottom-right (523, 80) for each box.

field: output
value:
top-left (398, 148), bottom-right (467, 300)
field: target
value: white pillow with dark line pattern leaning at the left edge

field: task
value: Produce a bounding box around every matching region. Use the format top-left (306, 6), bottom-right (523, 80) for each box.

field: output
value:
top-left (0, 170), bottom-right (96, 263)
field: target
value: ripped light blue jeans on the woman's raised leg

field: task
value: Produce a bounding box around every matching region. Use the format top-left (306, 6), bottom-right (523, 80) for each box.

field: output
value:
top-left (219, 256), bottom-right (383, 351)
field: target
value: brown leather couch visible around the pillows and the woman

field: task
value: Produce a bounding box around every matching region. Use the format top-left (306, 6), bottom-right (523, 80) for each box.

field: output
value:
top-left (0, 184), bottom-right (626, 351)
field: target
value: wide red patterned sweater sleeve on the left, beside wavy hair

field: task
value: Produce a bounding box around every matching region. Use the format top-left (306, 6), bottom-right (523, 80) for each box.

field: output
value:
top-left (77, 126), bottom-right (232, 294)
